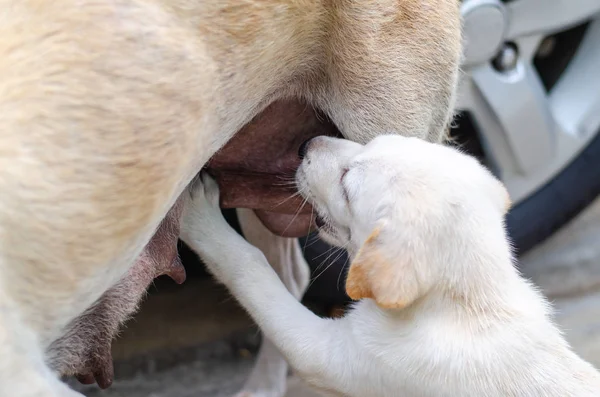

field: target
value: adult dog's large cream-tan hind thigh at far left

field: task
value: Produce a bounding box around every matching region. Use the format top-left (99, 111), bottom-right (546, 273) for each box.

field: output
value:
top-left (0, 0), bottom-right (216, 390)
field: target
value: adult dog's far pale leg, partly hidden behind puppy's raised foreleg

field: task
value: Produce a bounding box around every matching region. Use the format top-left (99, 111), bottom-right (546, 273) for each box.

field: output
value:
top-left (237, 209), bottom-right (310, 397)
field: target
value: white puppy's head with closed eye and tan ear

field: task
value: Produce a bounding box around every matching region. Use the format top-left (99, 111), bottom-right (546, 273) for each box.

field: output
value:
top-left (296, 135), bottom-right (510, 309)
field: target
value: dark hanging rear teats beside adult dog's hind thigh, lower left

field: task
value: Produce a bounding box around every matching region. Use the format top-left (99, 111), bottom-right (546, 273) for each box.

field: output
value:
top-left (48, 193), bottom-right (185, 389)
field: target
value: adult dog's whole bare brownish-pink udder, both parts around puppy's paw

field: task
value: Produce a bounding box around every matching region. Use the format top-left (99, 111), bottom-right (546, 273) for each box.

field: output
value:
top-left (48, 101), bottom-right (339, 389)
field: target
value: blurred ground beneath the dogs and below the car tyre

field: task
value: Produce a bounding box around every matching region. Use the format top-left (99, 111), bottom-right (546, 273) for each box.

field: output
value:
top-left (72, 199), bottom-right (600, 397)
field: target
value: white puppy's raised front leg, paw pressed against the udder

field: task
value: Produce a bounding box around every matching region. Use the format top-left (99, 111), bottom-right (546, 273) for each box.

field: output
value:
top-left (181, 175), bottom-right (358, 391)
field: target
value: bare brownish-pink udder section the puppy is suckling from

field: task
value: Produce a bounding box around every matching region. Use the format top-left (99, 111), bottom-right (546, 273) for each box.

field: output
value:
top-left (207, 100), bottom-right (340, 236)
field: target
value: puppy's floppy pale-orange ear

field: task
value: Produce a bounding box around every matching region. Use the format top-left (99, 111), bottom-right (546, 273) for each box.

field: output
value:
top-left (346, 227), bottom-right (422, 309)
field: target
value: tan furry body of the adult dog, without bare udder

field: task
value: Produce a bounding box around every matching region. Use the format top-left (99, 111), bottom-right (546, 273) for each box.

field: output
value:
top-left (0, 0), bottom-right (461, 396)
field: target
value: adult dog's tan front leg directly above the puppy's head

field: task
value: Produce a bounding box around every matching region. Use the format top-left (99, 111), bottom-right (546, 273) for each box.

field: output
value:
top-left (316, 0), bottom-right (461, 143)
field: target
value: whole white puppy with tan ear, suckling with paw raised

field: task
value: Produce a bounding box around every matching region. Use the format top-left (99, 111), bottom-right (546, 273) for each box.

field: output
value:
top-left (182, 136), bottom-right (600, 397)
